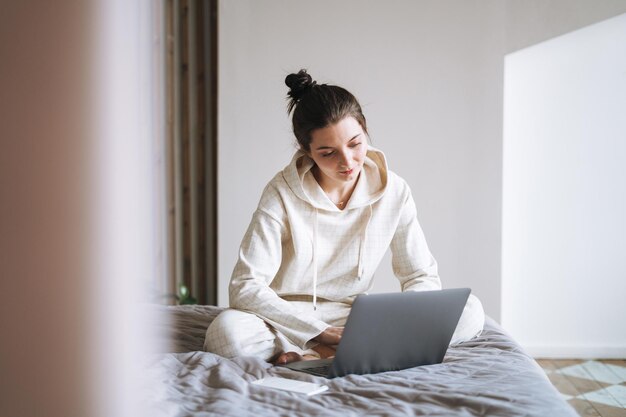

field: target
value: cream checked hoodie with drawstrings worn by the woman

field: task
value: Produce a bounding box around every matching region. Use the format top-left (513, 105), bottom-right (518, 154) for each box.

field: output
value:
top-left (229, 146), bottom-right (441, 349)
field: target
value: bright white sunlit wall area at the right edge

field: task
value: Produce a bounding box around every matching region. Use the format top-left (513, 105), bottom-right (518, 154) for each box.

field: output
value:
top-left (502, 14), bottom-right (626, 357)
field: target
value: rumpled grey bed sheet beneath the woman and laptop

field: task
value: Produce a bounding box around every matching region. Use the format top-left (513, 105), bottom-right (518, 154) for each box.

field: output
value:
top-left (145, 306), bottom-right (577, 417)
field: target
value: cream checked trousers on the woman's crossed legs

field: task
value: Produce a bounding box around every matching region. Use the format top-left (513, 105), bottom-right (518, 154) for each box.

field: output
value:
top-left (204, 295), bottom-right (485, 361)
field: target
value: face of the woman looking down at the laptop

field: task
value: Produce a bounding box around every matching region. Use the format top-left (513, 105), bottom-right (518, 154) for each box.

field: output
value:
top-left (308, 116), bottom-right (367, 187)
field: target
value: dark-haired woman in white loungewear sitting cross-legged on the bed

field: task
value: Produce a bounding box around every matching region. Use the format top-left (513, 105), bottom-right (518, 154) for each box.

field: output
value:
top-left (205, 70), bottom-right (484, 363)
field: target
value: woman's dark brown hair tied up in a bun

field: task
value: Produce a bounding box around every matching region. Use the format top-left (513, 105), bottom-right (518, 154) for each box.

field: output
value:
top-left (285, 69), bottom-right (367, 152)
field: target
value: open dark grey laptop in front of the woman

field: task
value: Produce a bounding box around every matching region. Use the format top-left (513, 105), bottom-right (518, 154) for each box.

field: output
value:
top-left (281, 288), bottom-right (471, 378)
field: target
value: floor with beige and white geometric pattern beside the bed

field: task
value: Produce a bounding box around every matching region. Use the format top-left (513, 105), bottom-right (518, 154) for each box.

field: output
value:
top-left (537, 359), bottom-right (626, 417)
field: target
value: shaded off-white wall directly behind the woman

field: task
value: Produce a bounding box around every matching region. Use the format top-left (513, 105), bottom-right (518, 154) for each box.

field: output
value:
top-left (218, 0), bottom-right (626, 320)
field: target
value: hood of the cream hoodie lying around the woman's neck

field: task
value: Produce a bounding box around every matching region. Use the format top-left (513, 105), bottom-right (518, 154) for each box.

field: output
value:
top-left (283, 146), bottom-right (387, 212)
